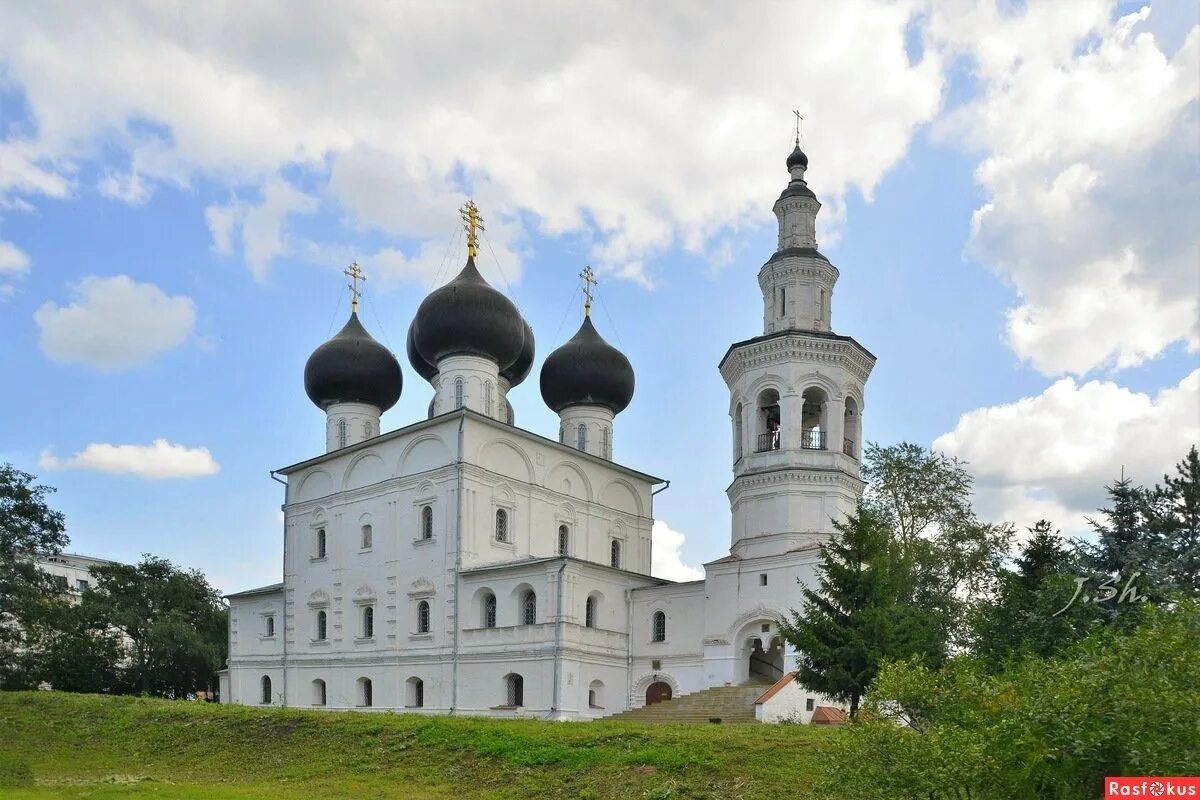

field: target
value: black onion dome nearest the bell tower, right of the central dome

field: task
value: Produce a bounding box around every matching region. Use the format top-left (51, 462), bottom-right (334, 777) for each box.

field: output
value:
top-left (541, 317), bottom-right (634, 414)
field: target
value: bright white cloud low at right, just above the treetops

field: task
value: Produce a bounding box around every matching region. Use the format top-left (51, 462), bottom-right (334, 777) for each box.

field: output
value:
top-left (934, 369), bottom-right (1200, 531)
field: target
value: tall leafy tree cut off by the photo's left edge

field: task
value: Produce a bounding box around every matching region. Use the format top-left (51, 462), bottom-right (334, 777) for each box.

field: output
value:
top-left (0, 464), bottom-right (68, 686)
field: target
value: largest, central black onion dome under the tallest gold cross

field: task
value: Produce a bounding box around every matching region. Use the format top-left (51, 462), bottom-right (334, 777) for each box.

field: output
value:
top-left (413, 258), bottom-right (524, 372)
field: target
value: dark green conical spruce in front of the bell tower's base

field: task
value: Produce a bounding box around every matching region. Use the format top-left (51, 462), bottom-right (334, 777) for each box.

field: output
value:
top-left (780, 507), bottom-right (895, 718)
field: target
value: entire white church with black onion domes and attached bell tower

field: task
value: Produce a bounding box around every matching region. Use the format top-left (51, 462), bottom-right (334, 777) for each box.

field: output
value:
top-left (221, 142), bottom-right (875, 722)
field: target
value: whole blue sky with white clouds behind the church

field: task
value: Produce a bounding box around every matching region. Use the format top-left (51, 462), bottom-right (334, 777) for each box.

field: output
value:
top-left (0, 1), bottom-right (1200, 590)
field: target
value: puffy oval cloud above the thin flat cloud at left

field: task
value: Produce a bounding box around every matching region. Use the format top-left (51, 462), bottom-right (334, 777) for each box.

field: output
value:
top-left (34, 275), bottom-right (196, 372)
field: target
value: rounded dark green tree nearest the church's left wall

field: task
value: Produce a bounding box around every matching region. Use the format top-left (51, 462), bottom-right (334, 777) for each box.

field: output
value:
top-left (83, 555), bottom-right (228, 697)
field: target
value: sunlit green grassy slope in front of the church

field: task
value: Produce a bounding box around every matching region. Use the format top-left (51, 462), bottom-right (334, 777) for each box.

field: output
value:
top-left (0, 692), bottom-right (839, 800)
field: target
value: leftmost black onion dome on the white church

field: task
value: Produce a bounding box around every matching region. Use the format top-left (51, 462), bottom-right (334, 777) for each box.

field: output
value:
top-left (304, 313), bottom-right (404, 411)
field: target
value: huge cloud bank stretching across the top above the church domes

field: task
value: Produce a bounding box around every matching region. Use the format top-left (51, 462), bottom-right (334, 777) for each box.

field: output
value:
top-left (0, 0), bottom-right (943, 283)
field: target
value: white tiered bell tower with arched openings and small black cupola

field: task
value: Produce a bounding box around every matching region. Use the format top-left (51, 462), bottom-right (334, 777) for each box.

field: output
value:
top-left (719, 137), bottom-right (875, 558)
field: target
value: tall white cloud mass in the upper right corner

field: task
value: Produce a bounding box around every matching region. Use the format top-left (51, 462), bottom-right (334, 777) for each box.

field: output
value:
top-left (930, 0), bottom-right (1200, 375)
